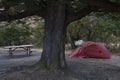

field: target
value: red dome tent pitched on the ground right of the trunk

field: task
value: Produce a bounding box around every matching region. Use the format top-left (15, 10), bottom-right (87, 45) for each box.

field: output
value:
top-left (69, 41), bottom-right (111, 59)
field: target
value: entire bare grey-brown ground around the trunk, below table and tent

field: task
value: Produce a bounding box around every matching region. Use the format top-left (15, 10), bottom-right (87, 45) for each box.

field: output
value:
top-left (0, 47), bottom-right (120, 80)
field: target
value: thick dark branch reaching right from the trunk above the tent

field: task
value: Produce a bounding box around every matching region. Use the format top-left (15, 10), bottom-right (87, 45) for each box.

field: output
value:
top-left (67, 0), bottom-right (120, 23)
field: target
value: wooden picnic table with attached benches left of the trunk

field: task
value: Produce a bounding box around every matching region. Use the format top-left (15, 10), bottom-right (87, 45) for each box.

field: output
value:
top-left (4, 45), bottom-right (33, 56)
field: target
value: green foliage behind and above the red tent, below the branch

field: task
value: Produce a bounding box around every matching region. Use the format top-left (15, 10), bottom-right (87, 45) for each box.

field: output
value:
top-left (68, 13), bottom-right (120, 42)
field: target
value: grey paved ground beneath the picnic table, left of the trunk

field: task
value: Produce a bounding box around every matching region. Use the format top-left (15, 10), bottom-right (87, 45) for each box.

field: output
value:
top-left (0, 48), bottom-right (42, 73)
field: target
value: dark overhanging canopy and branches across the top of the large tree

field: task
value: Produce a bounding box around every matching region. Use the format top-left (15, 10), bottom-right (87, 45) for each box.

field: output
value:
top-left (0, 0), bottom-right (120, 23)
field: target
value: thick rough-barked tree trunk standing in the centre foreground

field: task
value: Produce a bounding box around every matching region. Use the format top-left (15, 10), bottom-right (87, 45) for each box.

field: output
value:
top-left (39, 1), bottom-right (67, 68)
